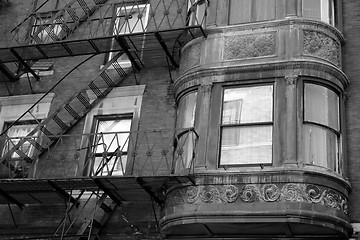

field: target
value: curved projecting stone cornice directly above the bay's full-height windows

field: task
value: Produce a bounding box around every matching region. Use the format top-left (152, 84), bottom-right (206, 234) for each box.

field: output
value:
top-left (174, 60), bottom-right (349, 96)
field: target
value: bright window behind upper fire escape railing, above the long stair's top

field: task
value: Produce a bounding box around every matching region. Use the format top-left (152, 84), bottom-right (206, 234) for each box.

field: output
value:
top-left (109, 4), bottom-right (149, 64)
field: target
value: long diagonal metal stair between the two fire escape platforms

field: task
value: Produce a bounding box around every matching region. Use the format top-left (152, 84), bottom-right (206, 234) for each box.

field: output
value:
top-left (0, 49), bottom-right (139, 176)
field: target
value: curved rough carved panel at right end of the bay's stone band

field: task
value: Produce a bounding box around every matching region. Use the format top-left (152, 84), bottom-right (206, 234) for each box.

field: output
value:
top-left (304, 30), bottom-right (340, 66)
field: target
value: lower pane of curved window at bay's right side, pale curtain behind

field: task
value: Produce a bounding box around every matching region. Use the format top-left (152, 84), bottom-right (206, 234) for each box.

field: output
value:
top-left (304, 124), bottom-right (339, 171)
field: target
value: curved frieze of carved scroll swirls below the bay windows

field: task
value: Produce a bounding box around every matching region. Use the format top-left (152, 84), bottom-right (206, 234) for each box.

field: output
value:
top-left (166, 183), bottom-right (347, 213)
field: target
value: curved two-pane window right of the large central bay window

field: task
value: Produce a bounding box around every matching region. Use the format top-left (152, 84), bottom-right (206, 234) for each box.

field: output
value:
top-left (304, 83), bottom-right (341, 172)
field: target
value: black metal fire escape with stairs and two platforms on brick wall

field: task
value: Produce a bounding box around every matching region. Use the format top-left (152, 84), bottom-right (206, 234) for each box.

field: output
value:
top-left (0, 0), bottom-right (208, 239)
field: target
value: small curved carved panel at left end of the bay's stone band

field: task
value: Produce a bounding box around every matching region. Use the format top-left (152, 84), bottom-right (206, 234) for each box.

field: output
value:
top-left (180, 43), bottom-right (201, 73)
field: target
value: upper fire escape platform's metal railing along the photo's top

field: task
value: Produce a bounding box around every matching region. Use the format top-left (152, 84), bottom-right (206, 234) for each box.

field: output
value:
top-left (1, 0), bottom-right (209, 47)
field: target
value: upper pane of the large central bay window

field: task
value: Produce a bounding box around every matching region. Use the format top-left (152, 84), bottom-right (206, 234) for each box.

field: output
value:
top-left (222, 85), bottom-right (273, 124)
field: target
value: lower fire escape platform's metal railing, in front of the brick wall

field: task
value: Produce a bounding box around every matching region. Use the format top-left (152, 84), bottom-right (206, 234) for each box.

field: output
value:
top-left (0, 128), bottom-right (199, 179)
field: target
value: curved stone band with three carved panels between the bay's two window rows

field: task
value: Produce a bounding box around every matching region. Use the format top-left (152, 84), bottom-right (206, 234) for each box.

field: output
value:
top-left (180, 19), bottom-right (344, 78)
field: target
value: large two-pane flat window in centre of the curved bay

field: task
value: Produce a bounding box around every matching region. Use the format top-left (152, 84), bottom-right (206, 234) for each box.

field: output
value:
top-left (220, 85), bottom-right (273, 166)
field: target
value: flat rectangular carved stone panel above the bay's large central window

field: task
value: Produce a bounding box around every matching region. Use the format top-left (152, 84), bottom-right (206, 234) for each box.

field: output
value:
top-left (224, 32), bottom-right (276, 60)
